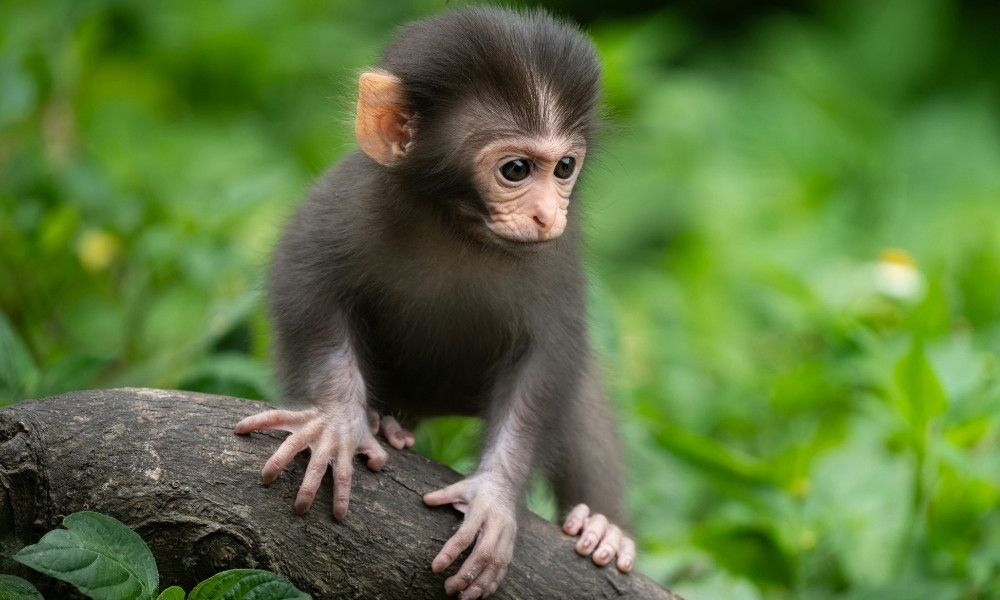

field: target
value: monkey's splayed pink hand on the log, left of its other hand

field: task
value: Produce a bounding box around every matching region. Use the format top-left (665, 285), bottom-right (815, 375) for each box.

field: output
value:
top-left (235, 402), bottom-right (400, 521)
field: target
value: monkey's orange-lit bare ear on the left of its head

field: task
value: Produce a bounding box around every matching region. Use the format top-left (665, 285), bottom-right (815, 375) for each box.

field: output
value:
top-left (354, 71), bottom-right (413, 166)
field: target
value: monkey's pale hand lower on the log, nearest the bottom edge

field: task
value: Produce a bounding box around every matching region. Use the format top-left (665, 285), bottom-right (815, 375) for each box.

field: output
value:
top-left (424, 473), bottom-right (517, 600)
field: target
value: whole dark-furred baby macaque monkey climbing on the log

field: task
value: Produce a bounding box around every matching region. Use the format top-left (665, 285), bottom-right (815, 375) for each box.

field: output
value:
top-left (236, 7), bottom-right (635, 598)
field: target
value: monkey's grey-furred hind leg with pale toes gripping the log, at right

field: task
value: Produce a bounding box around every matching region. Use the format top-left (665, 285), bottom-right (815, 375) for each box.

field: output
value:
top-left (549, 368), bottom-right (635, 572)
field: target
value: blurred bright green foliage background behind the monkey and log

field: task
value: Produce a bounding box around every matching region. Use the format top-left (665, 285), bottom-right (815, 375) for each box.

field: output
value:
top-left (0, 0), bottom-right (1000, 600)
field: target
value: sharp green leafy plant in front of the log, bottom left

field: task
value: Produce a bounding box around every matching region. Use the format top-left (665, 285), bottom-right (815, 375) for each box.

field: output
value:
top-left (0, 511), bottom-right (310, 600)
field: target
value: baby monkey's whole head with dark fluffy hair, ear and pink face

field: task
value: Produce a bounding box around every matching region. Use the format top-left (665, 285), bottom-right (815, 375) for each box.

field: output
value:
top-left (355, 12), bottom-right (600, 251)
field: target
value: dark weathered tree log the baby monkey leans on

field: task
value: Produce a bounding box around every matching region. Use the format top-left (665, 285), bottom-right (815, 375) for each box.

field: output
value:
top-left (0, 389), bottom-right (678, 600)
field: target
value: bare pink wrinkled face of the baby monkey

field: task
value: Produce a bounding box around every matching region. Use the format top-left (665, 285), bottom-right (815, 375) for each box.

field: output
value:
top-left (474, 136), bottom-right (586, 245)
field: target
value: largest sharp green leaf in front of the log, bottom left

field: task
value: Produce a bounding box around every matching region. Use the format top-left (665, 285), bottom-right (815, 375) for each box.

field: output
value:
top-left (14, 511), bottom-right (159, 600)
